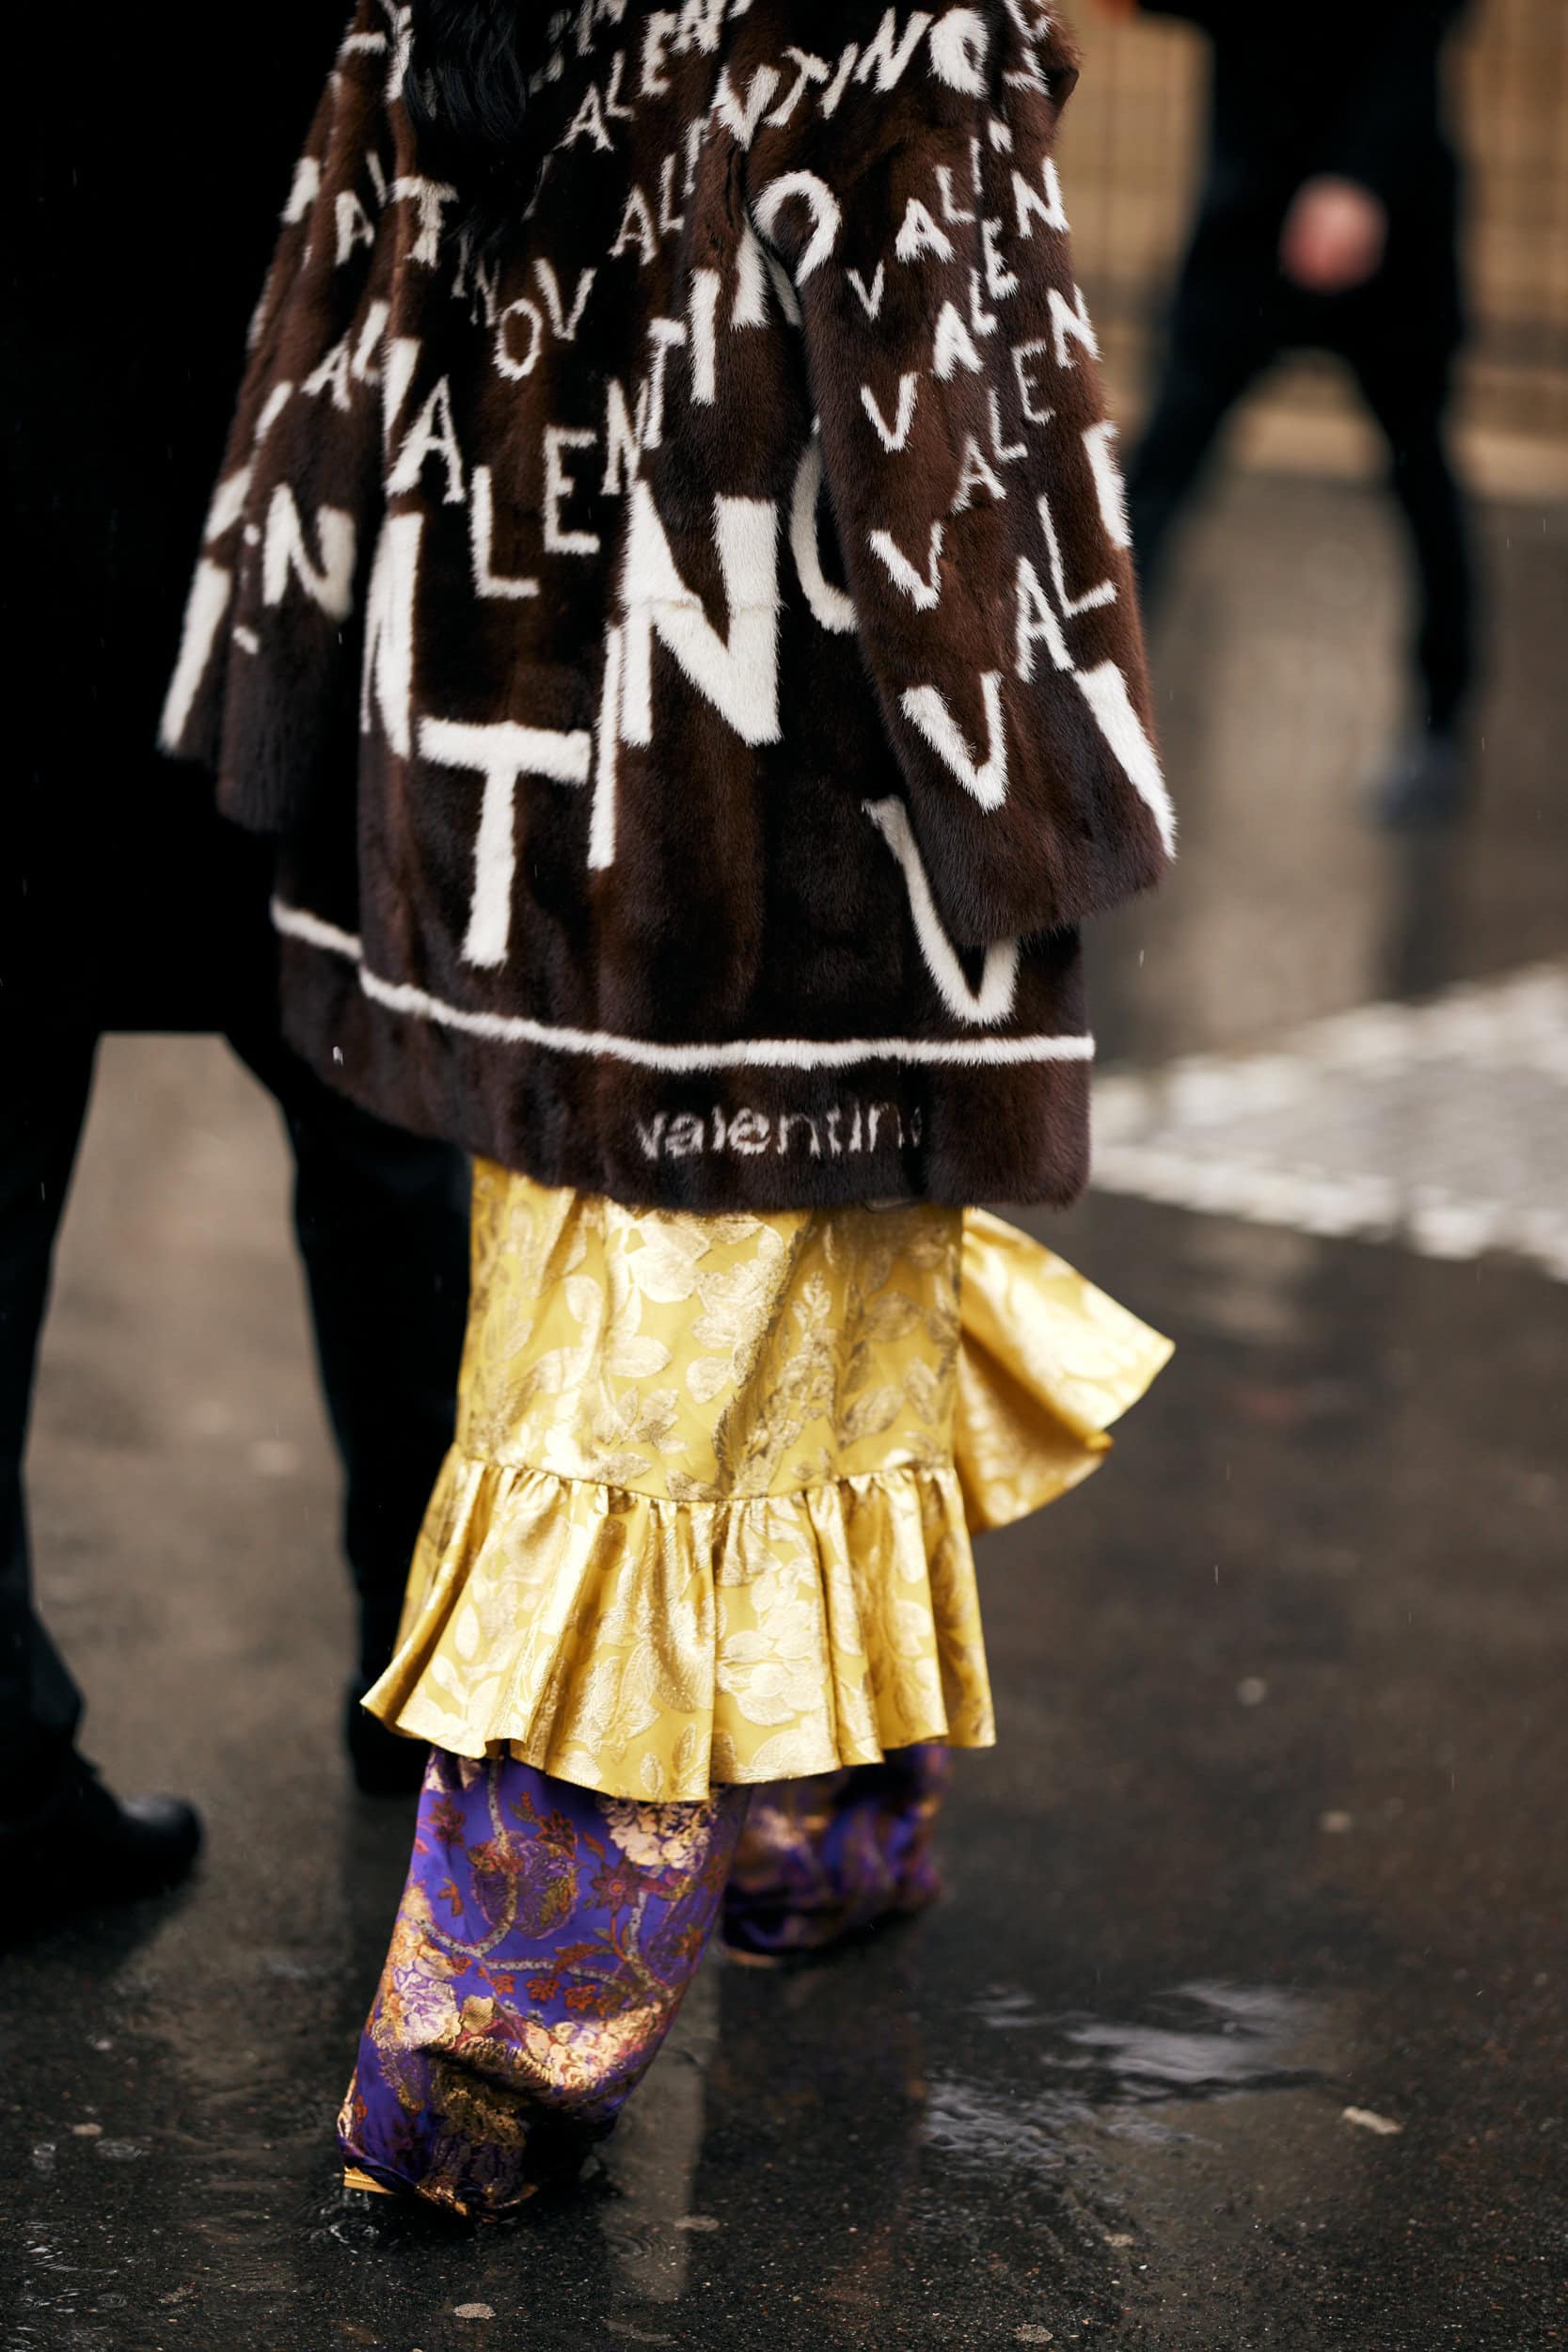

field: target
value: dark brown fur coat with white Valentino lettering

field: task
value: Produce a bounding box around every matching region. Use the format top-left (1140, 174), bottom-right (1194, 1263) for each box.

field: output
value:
top-left (165, 0), bottom-right (1171, 1212)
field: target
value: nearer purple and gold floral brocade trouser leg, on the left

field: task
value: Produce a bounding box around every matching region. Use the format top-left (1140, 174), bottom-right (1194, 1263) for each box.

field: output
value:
top-left (339, 1755), bottom-right (748, 2216)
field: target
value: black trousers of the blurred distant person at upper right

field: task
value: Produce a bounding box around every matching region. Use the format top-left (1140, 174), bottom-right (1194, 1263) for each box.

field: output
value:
top-left (1129, 283), bottom-right (1477, 729)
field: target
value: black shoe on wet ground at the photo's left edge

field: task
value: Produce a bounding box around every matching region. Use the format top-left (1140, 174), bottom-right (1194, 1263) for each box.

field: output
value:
top-left (0, 1757), bottom-right (202, 1915)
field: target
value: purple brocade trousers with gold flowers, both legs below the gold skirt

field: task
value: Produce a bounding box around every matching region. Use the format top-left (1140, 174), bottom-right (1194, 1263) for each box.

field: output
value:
top-left (339, 1748), bottom-right (950, 2216)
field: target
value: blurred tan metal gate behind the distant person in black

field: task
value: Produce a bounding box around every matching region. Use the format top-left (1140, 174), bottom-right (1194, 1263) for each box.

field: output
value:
top-left (1063, 0), bottom-right (1568, 452)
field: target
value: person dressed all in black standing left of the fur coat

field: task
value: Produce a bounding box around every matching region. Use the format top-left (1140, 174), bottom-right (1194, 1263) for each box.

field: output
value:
top-left (0, 0), bottom-right (467, 1913)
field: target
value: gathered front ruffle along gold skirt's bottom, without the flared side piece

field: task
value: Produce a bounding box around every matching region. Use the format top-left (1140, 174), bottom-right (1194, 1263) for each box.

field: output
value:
top-left (369, 1454), bottom-right (994, 1804)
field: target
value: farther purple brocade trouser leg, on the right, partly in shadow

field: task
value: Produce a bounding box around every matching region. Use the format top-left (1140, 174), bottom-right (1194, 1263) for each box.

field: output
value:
top-left (724, 1745), bottom-right (952, 1960)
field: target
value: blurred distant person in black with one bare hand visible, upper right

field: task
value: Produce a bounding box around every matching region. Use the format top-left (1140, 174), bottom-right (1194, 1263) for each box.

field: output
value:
top-left (1101, 0), bottom-right (1477, 823)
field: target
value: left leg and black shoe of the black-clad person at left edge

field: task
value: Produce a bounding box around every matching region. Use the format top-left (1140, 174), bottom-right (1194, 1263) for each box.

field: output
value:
top-left (0, 1025), bottom-right (199, 1931)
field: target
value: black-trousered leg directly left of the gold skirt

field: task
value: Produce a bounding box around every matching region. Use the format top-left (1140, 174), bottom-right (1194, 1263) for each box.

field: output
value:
top-left (230, 1030), bottom-right (467, 1795)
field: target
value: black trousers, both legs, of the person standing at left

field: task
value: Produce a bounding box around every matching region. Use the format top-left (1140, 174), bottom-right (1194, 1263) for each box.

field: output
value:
top-left (0, 1025), bottom-right (467, 1828)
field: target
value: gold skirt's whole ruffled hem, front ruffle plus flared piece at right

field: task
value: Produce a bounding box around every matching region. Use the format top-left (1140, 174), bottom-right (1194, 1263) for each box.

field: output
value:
top-left (367, 1212), bottom-right (1171, 1804)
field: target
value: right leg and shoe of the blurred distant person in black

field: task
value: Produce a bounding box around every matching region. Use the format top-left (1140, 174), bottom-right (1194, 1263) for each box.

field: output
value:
top-left (1352, 343), bottom-right (1477, 821)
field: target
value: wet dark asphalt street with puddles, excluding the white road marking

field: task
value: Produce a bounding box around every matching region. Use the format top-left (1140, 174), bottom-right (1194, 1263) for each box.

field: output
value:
top-left (0, 468), bottom-right (1568, 2352)
